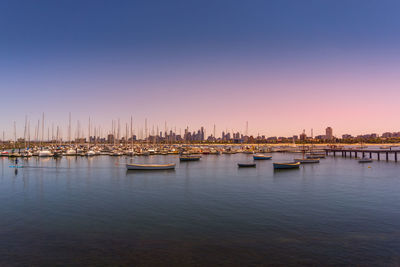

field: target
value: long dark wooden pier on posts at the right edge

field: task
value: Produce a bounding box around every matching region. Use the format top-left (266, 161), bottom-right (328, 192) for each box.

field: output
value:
top-left (325, 148), bottom-right (400, 162)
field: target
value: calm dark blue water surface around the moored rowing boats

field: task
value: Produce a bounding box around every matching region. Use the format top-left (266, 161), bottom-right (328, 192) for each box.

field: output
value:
top-left (0, 153), bottom-right (400, 266)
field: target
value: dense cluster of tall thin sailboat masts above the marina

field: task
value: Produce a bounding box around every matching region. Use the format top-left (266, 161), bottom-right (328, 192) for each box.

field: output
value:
top-left (1, 113), bottom-right (256, 147)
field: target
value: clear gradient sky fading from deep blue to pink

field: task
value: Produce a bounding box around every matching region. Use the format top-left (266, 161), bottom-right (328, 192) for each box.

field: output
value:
top-left (0, 0), bottom-right (400, 139)
